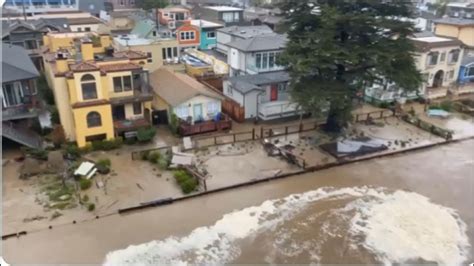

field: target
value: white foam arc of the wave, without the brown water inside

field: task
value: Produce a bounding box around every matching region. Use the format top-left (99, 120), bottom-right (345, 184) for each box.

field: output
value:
top-left (104, 187), bottom-right (469, 265)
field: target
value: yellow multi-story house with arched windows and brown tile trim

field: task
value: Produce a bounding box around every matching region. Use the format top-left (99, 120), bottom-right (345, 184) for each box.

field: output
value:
top-left (44, 33), bottom-right (153, 147)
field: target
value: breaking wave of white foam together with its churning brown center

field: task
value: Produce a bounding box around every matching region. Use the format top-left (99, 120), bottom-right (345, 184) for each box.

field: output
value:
top-left (104, 187), bottom-right (470, 265)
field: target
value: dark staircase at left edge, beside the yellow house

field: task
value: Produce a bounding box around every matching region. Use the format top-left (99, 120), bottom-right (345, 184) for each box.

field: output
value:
top-left (2, 122), bottom-right (43, 149)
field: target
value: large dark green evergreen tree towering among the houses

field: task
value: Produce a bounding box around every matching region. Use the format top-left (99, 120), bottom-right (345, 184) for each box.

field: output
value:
top-left (280, 0), bottom-right (421, 132)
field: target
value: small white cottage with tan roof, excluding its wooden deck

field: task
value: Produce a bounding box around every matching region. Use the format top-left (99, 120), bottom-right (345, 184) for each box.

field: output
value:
top-left (150, 68), bottom-right (224, 123)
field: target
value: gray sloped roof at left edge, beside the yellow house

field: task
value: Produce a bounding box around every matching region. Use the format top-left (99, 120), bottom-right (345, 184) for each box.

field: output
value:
top-left (2, 44), bottom-right (39, 83)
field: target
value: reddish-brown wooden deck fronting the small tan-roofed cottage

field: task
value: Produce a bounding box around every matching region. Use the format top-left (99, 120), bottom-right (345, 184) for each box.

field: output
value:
top-left (178, 113), bottom-right (232, 136)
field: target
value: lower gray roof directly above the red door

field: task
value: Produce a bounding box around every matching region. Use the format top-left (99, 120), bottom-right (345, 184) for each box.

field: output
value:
top-left (228, 71), bottom-right (290, 94)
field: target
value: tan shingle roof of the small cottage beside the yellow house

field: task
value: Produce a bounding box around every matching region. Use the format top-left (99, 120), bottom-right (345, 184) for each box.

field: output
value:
top-left (150, 68), bottom-right (224, 106)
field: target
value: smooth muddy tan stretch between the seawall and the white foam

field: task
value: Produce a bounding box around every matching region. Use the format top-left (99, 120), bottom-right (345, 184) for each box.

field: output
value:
top-left (3, 140), bottom-right (474, 264)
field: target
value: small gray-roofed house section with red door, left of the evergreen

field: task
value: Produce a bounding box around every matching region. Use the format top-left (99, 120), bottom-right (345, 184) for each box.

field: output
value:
top-left (224, 71), bottom-right (300, 120)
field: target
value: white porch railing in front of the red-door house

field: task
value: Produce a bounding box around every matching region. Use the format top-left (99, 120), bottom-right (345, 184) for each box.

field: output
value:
top-left (258, 101), bottom-right (302, 120)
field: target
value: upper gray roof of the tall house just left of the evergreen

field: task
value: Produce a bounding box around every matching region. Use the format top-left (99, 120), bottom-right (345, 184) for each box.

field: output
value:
top-left (227, 34), bottom-right (288, 52)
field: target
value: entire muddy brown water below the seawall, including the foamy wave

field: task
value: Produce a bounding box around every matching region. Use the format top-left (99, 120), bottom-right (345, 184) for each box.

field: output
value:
top-left (3, 140), bottom-right (474, 265)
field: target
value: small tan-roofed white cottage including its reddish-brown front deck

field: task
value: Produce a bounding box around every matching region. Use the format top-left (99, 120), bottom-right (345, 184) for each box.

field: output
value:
top-left (150, 68), bottom-right (231, 135)
